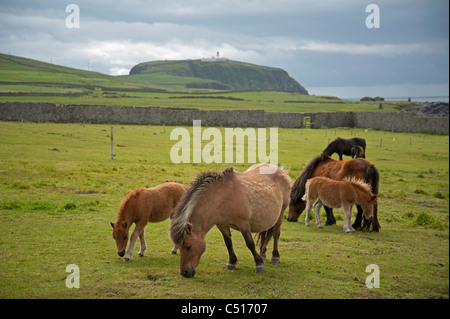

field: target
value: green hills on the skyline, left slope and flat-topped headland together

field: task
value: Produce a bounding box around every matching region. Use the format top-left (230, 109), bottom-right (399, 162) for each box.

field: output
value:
top-left (0, 53), bottom-right (308, 95)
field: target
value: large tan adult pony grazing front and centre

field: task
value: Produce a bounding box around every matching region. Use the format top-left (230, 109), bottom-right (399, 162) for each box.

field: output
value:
top-left (170, 164), bottom-right (291, 278)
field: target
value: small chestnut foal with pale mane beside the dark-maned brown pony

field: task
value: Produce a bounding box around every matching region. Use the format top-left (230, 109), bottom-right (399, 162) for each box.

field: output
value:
top-left (302, 176), bottom-right (377, 233)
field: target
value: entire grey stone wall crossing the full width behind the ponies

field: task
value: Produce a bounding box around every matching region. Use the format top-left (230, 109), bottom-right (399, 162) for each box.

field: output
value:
top-left (0, 102), bottom-right (449, 135)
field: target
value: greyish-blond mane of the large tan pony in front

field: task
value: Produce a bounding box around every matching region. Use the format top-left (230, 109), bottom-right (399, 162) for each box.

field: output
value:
top-left (170, 167), bottom-right (234, 246)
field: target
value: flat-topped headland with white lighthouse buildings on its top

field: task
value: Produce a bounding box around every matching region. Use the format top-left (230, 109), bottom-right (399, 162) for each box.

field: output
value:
top-left (128, 60), bottom-right (308, 95)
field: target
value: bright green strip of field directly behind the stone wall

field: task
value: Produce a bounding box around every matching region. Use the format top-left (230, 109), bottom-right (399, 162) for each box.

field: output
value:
top-left (0, 88), bottom-right (406, 113)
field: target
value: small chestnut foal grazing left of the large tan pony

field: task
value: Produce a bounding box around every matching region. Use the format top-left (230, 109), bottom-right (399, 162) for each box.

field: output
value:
top-left (110, 182), bottom-right (187, 261)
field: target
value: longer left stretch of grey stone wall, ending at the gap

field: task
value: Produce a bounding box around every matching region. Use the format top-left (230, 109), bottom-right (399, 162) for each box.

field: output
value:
top-left (0, 103), bottom-right (303, 128)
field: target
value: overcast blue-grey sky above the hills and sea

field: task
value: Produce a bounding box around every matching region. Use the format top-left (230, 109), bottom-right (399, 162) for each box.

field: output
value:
top-left (0, 0), bottom-right (449, 97)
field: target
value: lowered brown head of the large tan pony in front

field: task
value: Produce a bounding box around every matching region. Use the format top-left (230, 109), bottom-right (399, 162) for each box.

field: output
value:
top-left (179, 223), bottom-right (206, 278)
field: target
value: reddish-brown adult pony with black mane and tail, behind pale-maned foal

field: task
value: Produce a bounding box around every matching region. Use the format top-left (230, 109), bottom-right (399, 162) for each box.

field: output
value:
top-left (287, 153), bottom-right (381, 231)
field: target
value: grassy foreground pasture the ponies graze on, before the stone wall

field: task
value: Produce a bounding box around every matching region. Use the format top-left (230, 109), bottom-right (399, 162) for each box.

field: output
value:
top-left (0, 121), bottom-right (449, 299)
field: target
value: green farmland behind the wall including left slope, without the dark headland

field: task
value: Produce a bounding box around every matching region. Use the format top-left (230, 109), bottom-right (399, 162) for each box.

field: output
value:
top-left (0, 54), bottom-right (414, 112)
